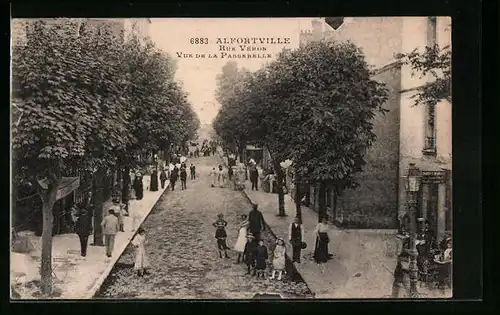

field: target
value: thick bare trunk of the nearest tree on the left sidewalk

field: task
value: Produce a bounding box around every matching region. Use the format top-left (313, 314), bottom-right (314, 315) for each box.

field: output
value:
top-left (39, 185), bottom-right (58, 295)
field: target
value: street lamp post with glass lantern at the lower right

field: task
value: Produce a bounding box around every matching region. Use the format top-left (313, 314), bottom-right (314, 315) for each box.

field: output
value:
top-left (405, 163), bottom-right (421, 298)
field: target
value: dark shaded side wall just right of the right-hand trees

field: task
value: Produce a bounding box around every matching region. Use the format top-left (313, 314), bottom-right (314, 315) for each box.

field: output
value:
top-left (336, 65), bottom-right (401, 228)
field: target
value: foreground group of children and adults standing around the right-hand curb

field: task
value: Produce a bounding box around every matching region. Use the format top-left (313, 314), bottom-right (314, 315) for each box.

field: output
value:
top-left (213, 204), bottom-right (332, 280)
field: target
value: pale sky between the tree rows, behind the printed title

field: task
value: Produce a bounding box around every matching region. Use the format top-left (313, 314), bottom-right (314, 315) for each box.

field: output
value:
top-left (150, 18), bottom-right (311, 124)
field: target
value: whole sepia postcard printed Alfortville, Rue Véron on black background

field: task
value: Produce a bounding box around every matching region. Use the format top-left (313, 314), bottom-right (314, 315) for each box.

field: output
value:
top-left (10, 16), bottom-right (453, 300)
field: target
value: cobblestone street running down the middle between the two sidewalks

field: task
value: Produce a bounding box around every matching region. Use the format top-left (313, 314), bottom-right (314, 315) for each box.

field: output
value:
top-left (96, 157), bottom-right (311, 299)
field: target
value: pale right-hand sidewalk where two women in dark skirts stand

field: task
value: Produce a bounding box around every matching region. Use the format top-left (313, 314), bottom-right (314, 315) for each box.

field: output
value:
top-left (244, 182), bottom-right (451, 299)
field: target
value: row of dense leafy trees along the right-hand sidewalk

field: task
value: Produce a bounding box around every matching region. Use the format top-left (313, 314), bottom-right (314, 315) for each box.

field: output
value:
top-left (214, 42), bottom-right (387, 219)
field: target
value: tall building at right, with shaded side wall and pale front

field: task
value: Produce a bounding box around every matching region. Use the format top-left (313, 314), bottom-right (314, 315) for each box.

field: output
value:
top-left (299, 17), bottom-right (451, 237)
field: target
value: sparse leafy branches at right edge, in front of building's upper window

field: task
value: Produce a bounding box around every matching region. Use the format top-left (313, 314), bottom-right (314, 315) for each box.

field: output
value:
top-left (396, 44), bottom-right (451, 106)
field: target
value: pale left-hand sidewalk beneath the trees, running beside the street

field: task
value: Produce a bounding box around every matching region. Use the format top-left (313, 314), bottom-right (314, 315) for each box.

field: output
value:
top-left (10, 176), bottom-right (168, 299)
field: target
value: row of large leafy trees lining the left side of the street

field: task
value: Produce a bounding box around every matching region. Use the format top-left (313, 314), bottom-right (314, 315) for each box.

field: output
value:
top-left (12, 19), bottom-right (199, 294)
